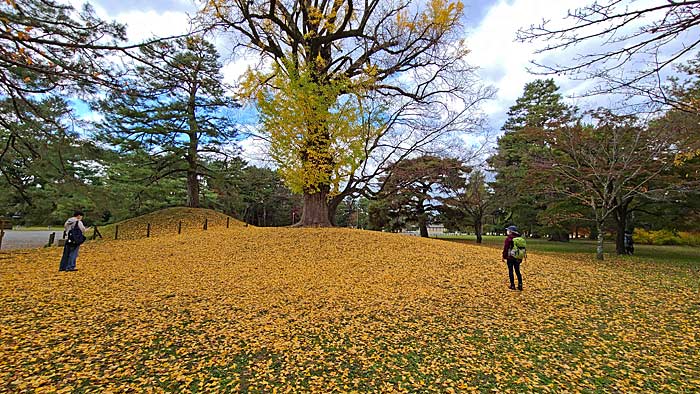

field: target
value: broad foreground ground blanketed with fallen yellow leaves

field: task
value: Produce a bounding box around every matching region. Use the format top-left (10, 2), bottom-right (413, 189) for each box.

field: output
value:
top-left (0, 227), bottom-right (700, 392)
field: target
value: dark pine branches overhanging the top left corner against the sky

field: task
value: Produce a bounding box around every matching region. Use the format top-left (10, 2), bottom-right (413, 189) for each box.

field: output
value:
top-left (0, 0), bottom-right (126, 109)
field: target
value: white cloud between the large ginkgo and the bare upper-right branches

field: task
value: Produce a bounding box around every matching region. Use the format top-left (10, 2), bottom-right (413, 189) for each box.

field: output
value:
top-left (467, 0), bottom-right (692, 130)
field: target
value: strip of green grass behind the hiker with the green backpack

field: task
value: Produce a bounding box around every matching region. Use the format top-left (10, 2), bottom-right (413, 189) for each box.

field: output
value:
top-left (436, 235), bottom-right (700, 269)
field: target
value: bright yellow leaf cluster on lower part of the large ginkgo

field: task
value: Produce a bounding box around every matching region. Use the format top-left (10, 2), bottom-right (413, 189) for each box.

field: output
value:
top-left (242, 60), bottom-right (380, 194)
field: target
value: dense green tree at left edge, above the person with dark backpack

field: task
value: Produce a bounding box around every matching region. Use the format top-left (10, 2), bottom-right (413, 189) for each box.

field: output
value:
top-left (0, 97), bottom-right (123, 224)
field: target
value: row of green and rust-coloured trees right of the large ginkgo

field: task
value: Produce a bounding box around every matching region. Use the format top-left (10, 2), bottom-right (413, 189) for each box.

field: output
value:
top-left (369, 66), bottom-right (700, 258)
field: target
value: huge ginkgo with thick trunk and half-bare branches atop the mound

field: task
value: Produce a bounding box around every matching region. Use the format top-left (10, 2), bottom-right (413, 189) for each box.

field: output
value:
top-left (202, 0), bottom-right (492, 226)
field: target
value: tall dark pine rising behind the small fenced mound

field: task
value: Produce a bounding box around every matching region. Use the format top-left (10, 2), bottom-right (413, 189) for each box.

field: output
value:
top-left (98, 36), bottom-right (237, 207)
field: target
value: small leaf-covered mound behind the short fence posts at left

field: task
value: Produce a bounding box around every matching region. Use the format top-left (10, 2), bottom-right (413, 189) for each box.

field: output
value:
top-left (87, 207), bottom-right (245, 240)
